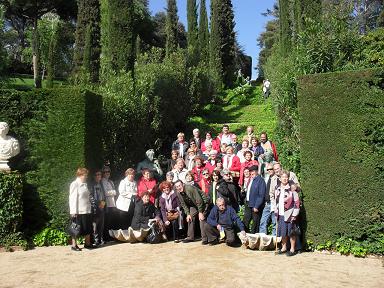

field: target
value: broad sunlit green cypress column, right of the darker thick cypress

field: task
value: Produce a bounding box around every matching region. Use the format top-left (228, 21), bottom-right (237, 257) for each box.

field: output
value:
top-left (107, 0), bottom-right (136, 73)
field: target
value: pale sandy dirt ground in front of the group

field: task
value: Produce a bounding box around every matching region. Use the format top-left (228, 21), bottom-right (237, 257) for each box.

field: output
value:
top-left (0, 242), bottom-right (384, 288)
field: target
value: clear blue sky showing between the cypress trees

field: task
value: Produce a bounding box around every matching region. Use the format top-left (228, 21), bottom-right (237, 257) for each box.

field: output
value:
top-left (149, 0), bottom-right (275, 79)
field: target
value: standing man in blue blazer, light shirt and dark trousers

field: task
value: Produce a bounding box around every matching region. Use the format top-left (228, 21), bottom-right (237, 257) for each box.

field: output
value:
top-left (244, 165), bottom-right (267, 234)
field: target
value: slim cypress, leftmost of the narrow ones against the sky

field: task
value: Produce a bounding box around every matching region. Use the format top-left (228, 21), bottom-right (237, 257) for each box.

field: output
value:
top-left (165, 0), bottom-right (178, 56)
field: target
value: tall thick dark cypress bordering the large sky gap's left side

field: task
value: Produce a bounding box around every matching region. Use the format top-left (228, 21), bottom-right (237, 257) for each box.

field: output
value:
top-left (210, 0), bottom-right (235, 87)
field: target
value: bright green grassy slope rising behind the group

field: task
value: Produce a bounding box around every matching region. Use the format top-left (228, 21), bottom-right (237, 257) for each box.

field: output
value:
top-left (189, 87), bottom-right (276, 140)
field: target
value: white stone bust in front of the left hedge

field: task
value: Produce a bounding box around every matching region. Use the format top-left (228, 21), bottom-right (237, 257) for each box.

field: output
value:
top-left (0, 122), bottom-right (20, 171)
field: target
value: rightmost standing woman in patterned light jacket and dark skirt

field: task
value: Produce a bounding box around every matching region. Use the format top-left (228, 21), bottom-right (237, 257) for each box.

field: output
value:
top-left (275, 171), bottom-right (300, 256)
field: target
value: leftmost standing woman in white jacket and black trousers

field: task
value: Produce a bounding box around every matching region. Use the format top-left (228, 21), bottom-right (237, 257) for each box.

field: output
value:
top-left (69, 168), bottom-right (93, 251)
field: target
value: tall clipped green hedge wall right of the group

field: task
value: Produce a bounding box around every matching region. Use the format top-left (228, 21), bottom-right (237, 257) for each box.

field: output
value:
top-left (298, 70), bottom-right (384, 243)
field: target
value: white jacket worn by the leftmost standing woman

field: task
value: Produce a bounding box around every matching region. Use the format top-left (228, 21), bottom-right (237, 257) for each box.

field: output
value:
top-left (69, 178), bottom-right (91, 215)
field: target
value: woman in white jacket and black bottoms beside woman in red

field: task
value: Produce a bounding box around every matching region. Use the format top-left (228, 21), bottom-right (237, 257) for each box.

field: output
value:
top-left (116, 168), bottom-right (137, 230)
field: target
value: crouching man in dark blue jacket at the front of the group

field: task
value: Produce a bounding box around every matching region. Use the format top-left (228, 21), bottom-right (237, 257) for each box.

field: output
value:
top-left (203, 197), bottom-right (245, 246)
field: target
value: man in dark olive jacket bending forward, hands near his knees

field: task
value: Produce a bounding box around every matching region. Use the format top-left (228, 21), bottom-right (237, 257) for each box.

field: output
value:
top-left (174, 180), bottom-right (208, 243)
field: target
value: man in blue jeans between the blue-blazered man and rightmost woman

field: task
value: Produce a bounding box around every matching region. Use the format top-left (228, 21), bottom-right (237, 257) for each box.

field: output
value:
top-left (259, 163), bottom-right (276, 236)
